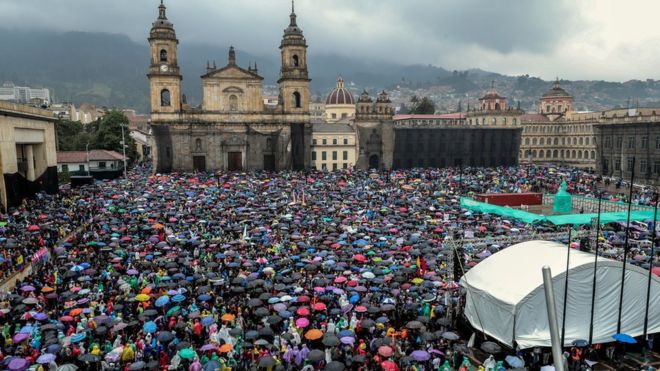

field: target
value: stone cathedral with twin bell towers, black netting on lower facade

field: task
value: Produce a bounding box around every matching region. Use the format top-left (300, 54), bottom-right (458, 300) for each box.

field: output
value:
top-left (147, 0), bottom-right (312, 173)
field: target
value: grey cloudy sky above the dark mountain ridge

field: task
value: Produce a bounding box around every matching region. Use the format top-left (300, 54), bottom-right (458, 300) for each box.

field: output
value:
top-left (0, 0), bottom-right (660, 81)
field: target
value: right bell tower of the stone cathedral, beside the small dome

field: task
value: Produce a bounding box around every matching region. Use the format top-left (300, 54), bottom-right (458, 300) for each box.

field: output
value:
top-left (277, 0), bottom-right (311, 114)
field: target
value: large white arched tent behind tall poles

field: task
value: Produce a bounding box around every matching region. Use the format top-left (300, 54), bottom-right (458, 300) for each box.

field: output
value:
top-left (461, 241), bottom-right (660, 349)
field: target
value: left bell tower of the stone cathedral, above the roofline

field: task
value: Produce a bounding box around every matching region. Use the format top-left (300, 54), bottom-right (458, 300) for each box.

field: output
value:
top-left (147, 0), bottom-right (181, 113)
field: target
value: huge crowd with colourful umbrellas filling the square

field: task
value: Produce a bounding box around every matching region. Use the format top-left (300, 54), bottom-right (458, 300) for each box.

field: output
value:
top-left (0, 167), bottom-right (653, 371)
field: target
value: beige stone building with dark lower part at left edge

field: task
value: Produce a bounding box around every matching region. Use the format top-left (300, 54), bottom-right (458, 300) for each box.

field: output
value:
top-left (0, 101), bottom-right (58, 210)
